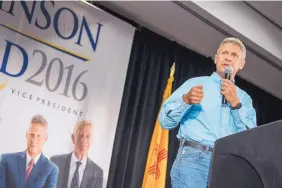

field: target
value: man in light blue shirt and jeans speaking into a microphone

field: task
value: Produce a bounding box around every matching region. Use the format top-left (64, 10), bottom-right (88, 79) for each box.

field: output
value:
top-left (159, 38), bottom-right (256, 188)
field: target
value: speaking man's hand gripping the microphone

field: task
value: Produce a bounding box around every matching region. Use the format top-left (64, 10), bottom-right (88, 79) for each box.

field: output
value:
top-left (221, 79), bottom-right (240, 107)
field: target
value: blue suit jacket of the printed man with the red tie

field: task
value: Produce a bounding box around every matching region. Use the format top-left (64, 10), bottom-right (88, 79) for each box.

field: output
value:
top-left (0, 151), bottom-right (59, 188)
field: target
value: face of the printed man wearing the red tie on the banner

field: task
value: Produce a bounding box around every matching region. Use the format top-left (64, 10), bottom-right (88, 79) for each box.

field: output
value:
top-left (26, 123), bottom-right (48, 157)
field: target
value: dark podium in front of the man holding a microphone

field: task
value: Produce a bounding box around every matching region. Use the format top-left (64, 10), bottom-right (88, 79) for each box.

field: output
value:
top-left (208, 121), bottom-right (282, 188)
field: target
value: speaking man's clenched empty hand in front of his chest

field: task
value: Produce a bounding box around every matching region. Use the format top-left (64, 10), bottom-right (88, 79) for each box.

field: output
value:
top-left (182, 85), bottom-right (204, 104)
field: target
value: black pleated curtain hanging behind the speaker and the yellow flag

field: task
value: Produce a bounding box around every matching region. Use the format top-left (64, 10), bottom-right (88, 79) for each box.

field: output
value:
top-left (107, 29), bottom-right (282, 188)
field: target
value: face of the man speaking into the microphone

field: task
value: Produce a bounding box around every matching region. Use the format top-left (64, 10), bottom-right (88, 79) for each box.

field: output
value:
top-left (215, 43), bottom-right (245, 75)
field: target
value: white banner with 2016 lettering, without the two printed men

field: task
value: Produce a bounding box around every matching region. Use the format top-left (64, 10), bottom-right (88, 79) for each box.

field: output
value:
top-left (0, 1), bottom-right (134, 187)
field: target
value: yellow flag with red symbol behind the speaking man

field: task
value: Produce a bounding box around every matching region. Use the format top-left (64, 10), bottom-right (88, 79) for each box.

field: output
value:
top-left (142, 63), bottom-right (175, 188)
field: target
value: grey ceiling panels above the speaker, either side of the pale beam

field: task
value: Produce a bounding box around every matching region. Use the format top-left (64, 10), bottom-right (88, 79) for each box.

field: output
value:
top-left (99, 1), bottom-right (282, 99)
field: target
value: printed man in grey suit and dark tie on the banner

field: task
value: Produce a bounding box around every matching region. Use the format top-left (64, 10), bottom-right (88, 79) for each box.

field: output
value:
top-left (50, 121), bottom-right (103, 188)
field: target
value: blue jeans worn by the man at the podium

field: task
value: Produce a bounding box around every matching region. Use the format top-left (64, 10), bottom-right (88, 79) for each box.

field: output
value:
top-left (170, 144), bottom-right (212, 188)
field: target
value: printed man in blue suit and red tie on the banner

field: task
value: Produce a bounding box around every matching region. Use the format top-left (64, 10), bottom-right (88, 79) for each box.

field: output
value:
top-left (0, 115), bottom-right (59, 188)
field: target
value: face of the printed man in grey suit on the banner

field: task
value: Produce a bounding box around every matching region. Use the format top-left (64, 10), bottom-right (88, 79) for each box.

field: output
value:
top-left (72, 125), bottom-right (93, 155)
